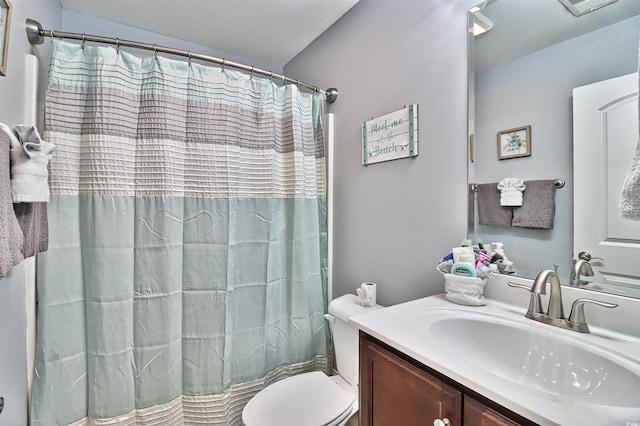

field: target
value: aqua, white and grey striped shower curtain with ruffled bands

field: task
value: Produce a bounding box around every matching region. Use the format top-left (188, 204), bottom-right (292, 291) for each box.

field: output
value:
top-left (31, 40), bottom-right (328, 426)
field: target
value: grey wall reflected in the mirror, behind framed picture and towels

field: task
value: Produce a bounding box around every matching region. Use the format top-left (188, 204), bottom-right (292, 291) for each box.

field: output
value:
top-left (473, 16), bottom-right (640, 282)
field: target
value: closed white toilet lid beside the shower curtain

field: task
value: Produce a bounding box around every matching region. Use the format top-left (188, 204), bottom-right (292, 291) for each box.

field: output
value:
top-left (242, 371), bottom-right (355, 426)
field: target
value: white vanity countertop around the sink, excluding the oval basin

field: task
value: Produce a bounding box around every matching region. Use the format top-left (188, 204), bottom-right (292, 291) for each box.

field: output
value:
top-left (350, 295), bottom-right (640, 426)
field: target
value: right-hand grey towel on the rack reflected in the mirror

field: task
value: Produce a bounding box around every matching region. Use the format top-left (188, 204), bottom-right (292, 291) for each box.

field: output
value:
top-left (513, 179), bottom-right (556, 229)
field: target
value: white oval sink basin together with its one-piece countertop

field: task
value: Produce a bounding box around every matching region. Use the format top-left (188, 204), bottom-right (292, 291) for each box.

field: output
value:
top-left (350, 295), bottom-right (640, 426)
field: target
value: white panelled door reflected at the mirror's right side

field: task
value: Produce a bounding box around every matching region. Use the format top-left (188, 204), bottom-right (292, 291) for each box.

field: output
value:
top-left (573, 73), bottom-right (640, 294)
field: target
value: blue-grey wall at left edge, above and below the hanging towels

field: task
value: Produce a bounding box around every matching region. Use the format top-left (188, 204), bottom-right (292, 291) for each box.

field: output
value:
top-left (0, 0), bottom-right (60, 426)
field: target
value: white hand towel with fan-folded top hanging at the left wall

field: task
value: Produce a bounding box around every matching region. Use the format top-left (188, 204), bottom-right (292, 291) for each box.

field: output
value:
top-left (2, 124), bottom-right (55, 203)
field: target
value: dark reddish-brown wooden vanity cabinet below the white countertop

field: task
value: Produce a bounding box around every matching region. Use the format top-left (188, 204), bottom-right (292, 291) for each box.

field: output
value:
top-left (360, 332), bottom-right (534, 426)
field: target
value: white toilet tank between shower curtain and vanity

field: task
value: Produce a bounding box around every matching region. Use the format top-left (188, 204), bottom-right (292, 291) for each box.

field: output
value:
top-left (328, 294), bottom-right (382, 385)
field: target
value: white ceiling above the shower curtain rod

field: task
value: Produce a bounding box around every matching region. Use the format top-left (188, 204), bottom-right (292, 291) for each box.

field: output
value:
top-left (60, 0), bottom-right (358, 69)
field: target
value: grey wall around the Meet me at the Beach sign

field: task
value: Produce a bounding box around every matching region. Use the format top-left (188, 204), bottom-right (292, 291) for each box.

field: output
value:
top-left (285, 0), bottom-right (478, 305)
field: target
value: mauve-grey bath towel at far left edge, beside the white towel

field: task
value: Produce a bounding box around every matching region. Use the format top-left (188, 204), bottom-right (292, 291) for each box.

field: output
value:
top-left (0, 131), bottom-right (24, 277)
